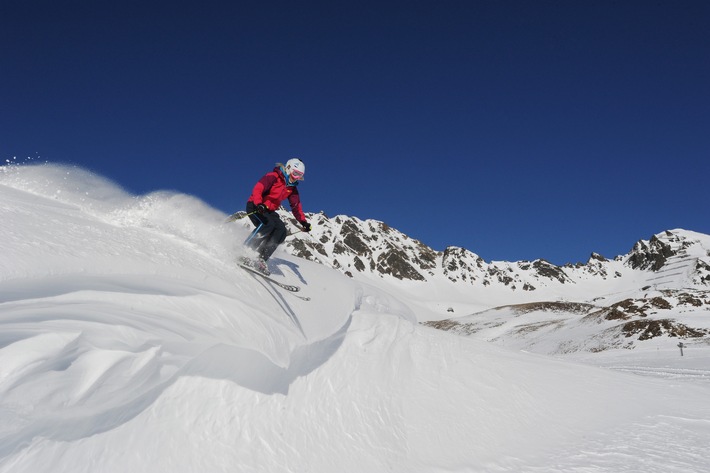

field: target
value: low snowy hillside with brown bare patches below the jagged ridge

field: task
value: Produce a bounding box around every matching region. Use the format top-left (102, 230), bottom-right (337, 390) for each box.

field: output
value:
top-left (424, 289), bottom-right (710, 355)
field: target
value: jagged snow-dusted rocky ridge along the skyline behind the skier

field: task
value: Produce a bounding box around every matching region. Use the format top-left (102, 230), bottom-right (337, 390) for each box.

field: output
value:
top-left (262, 211), bottom-right (710, 292)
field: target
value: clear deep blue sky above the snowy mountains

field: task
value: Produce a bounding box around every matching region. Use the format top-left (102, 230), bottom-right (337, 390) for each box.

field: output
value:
top-left (0, 0), bottom-right (710, 264)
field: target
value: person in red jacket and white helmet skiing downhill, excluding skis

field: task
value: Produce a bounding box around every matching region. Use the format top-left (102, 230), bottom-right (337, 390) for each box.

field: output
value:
top-left (242, 158), bottom-right (311, 275)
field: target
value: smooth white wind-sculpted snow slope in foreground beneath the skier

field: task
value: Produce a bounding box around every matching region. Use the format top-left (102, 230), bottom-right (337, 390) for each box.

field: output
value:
top-left (0, 165), bottom-right (710, 473)
